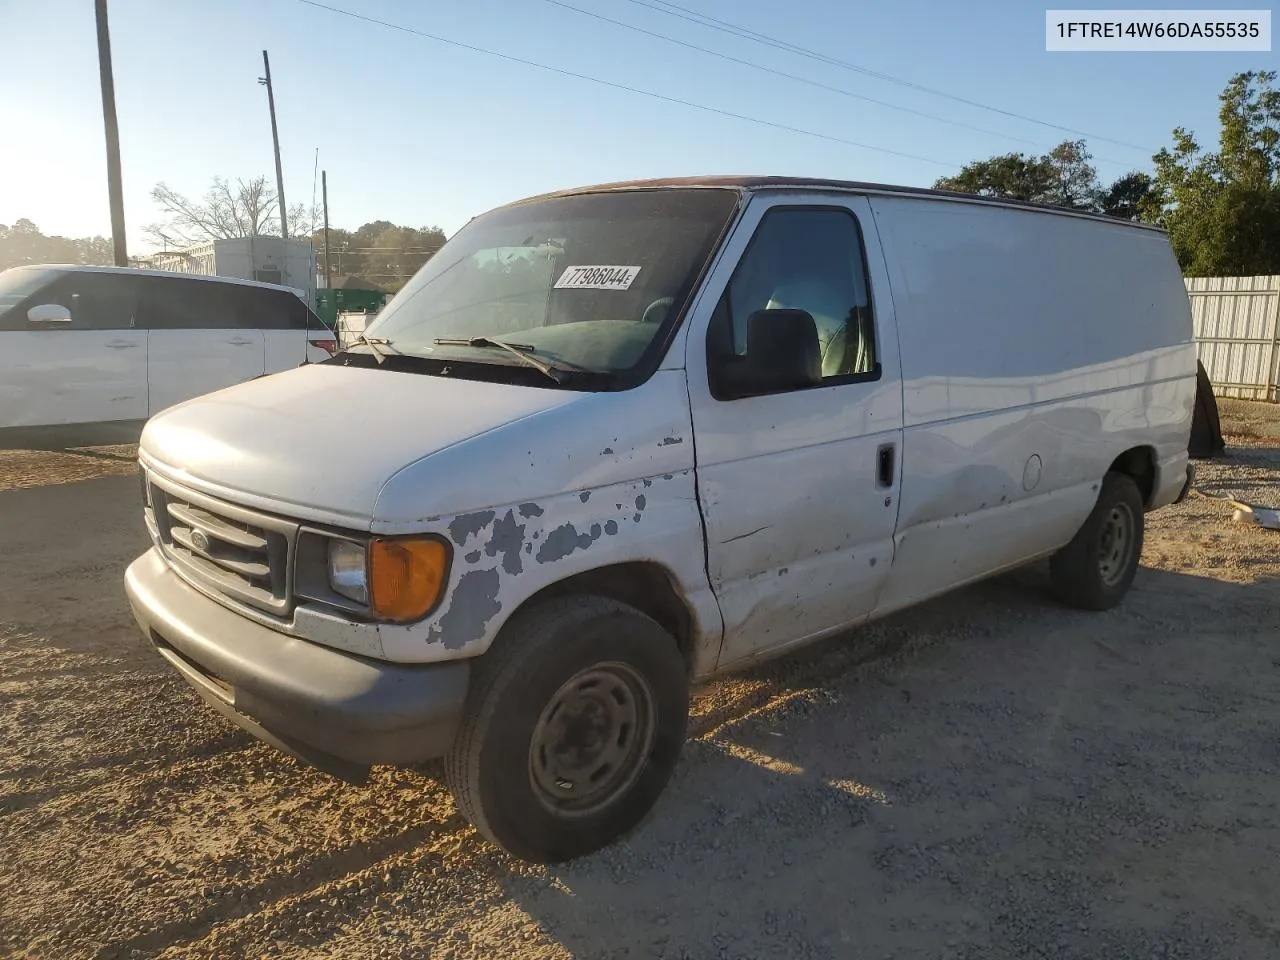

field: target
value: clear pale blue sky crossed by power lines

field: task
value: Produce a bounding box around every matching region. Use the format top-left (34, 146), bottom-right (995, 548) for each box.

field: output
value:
top-left (0, 0), bottom-right (1275, 253)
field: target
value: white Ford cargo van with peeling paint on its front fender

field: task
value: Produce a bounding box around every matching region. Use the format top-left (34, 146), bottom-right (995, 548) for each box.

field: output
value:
top-left (125, 178), bottom-right (1196, 861)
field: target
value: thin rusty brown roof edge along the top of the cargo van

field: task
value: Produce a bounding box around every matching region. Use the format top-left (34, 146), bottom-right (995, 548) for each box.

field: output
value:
top-left (511, 175), bottom-right (1165, 233)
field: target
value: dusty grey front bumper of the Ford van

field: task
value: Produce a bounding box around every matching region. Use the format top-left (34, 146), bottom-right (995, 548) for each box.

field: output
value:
top-left (124, 549), bottom-right (471, 782)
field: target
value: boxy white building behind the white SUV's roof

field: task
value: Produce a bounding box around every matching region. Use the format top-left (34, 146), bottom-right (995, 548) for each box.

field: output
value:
top-left (146, 237), bottom-right (316, 308)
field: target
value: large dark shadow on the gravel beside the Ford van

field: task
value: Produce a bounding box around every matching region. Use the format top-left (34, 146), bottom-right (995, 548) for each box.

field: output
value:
top-left (486, 568), bottom-right (1280, 957)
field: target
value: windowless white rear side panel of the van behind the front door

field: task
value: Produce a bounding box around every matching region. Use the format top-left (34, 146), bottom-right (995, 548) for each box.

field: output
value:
top-left (872, 197), bottom-right (1196, 609)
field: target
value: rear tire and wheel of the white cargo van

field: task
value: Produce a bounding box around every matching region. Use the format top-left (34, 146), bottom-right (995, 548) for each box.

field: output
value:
top-left (1050, 472), bottom-right (1144, 611)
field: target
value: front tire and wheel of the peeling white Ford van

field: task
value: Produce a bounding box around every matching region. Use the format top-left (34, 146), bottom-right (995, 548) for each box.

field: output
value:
top-left (444, 596), bottom-right (689, 863)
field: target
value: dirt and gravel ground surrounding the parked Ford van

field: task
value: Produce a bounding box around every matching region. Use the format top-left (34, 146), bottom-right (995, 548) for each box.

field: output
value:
top-left (0, 403), bottom-right (1280, 960)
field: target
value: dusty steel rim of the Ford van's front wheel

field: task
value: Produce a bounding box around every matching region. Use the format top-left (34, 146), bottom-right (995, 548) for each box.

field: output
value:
top-left (529, 662), bottom-right (655, 817)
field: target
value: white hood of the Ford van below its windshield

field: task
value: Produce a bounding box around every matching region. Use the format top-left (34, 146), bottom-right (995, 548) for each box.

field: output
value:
top-left (140, 364), bottom-right (588, 529)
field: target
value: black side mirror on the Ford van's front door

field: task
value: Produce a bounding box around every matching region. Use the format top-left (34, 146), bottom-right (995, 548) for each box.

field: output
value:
top-left (723, 310), bottom-right (822, 397)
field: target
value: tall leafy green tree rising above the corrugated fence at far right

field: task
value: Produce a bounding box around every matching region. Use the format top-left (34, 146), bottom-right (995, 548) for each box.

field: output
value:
top-left (1142, 70), bottom-right (1280, 276)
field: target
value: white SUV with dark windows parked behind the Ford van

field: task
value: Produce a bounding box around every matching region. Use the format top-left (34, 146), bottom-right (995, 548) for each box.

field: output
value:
top-left (0, 265), bottom-right (337, 447)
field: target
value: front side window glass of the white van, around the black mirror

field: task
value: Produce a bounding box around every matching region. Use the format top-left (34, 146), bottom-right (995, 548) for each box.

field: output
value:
top-left (708, 207), bottom-right (877, 380)
